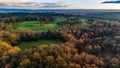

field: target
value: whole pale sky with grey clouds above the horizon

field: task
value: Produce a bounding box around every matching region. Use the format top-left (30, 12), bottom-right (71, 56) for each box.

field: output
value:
top-left (0, 0), bottom-right (120, 9)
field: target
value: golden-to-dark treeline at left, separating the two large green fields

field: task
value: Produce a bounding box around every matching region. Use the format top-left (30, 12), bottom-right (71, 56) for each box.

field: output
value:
top-left (0, 31), bottom-right (67, 46)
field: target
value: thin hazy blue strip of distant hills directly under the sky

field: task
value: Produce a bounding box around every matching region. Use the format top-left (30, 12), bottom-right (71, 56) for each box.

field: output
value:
top-left (0, 8), bottom-right (120, 13)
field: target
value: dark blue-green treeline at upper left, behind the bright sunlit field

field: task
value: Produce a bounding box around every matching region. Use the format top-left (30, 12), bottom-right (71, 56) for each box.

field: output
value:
top-left (0, 13), bottom-right (72, 23)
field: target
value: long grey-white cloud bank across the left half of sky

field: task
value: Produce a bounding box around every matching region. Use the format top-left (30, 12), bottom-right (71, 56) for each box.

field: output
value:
top-left (0, 0), bottom-right (69, 8)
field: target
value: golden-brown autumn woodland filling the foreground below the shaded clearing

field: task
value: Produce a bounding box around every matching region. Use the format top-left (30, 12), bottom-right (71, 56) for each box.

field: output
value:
top-left (1, 43), bottom-right (104, 68)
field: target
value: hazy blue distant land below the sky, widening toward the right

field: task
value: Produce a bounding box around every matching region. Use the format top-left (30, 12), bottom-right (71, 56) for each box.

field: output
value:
top-left (0, 8), bottom-right (120, 21)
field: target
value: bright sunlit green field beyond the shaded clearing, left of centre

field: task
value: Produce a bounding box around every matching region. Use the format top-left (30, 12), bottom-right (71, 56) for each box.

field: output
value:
top-left (16, 21), bottom-right (58, 31)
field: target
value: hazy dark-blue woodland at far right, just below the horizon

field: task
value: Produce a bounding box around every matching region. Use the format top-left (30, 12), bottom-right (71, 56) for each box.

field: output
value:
top-left (80, 12), bottom-right (120, 21)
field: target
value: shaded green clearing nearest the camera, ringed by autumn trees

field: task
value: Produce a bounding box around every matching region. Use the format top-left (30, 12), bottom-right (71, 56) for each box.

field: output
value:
top-left (18, 40), bottom-right (63, 50)
